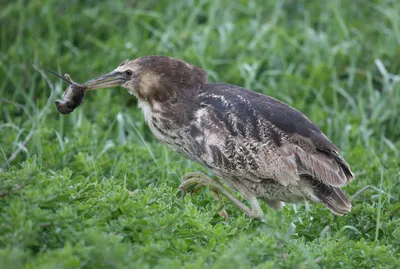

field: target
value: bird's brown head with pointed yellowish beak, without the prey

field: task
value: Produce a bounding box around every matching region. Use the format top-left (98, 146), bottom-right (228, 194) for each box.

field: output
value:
top-left (83, 56), bottom-right (207, 103)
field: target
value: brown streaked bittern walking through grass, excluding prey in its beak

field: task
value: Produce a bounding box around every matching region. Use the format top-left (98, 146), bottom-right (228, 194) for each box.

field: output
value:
top-left (76, 55), bottom-right (354, 219)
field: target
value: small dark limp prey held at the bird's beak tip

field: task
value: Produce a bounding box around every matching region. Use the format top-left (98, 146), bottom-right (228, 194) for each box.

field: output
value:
top-left (49, 70), bottom-right (87, 114)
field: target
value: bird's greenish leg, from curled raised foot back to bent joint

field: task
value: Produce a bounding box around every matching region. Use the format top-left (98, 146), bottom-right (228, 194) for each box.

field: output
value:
top-left (179, 172), bottom-right (264, 218)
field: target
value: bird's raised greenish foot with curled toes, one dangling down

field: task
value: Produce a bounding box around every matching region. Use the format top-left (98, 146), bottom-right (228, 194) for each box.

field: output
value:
top-left (179, 172), bottom-right (229, 221)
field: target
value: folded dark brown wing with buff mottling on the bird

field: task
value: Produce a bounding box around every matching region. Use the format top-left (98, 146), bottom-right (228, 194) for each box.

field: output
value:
top-left (197, 84), bottom-right (354, 187)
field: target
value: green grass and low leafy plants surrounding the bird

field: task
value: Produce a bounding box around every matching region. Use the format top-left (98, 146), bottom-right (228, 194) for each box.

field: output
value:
top-left (0, 0), bottom-right (400, 268)
